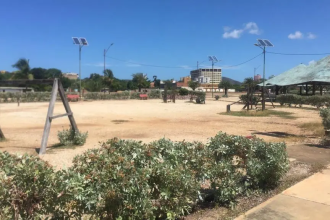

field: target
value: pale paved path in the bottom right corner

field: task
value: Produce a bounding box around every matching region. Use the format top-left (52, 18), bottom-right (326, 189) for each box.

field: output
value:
top-left (236, 166), bottom-right (330, 220)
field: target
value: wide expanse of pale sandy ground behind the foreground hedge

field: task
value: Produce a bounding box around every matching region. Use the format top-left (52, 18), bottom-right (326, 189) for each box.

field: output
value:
top-left (0, 95), bottom-right (321, 167)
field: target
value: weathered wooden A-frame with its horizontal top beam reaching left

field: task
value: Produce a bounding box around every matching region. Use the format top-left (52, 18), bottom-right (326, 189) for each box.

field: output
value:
top-left (0, 78), bottom-right (79, 155)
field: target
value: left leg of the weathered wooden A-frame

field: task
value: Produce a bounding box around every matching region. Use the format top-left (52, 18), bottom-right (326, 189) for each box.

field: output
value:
top-left (39, 79), bottom-right (58, 155)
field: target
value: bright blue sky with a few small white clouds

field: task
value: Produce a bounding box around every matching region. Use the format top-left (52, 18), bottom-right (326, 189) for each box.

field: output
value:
top-left (0, 0), bottom-right (330, 81)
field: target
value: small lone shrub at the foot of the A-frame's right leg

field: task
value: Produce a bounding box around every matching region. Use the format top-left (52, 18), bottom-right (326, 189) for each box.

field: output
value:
top-left (57, 128), bottom-right (88, 146)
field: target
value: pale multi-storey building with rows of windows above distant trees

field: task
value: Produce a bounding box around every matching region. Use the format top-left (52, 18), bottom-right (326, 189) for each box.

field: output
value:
top-left (190, 68), bottom-right (222, 84)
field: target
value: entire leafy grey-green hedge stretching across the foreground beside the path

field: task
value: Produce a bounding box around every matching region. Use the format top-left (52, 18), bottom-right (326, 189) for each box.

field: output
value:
top-left (0, 133), bottom-right (288, 219)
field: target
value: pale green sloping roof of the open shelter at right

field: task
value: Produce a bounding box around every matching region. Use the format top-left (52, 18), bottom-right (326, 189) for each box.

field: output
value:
top-left (259, 56), bottom-right (330, 86)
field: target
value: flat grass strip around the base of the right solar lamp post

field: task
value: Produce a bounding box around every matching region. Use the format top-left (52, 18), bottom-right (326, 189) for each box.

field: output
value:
top-left (220, 110), bottom-right (296, 119)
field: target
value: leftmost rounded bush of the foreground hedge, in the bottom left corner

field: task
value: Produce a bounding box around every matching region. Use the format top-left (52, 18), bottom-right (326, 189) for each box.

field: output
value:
top-left (0, 152), bottom-right (61, 219)
